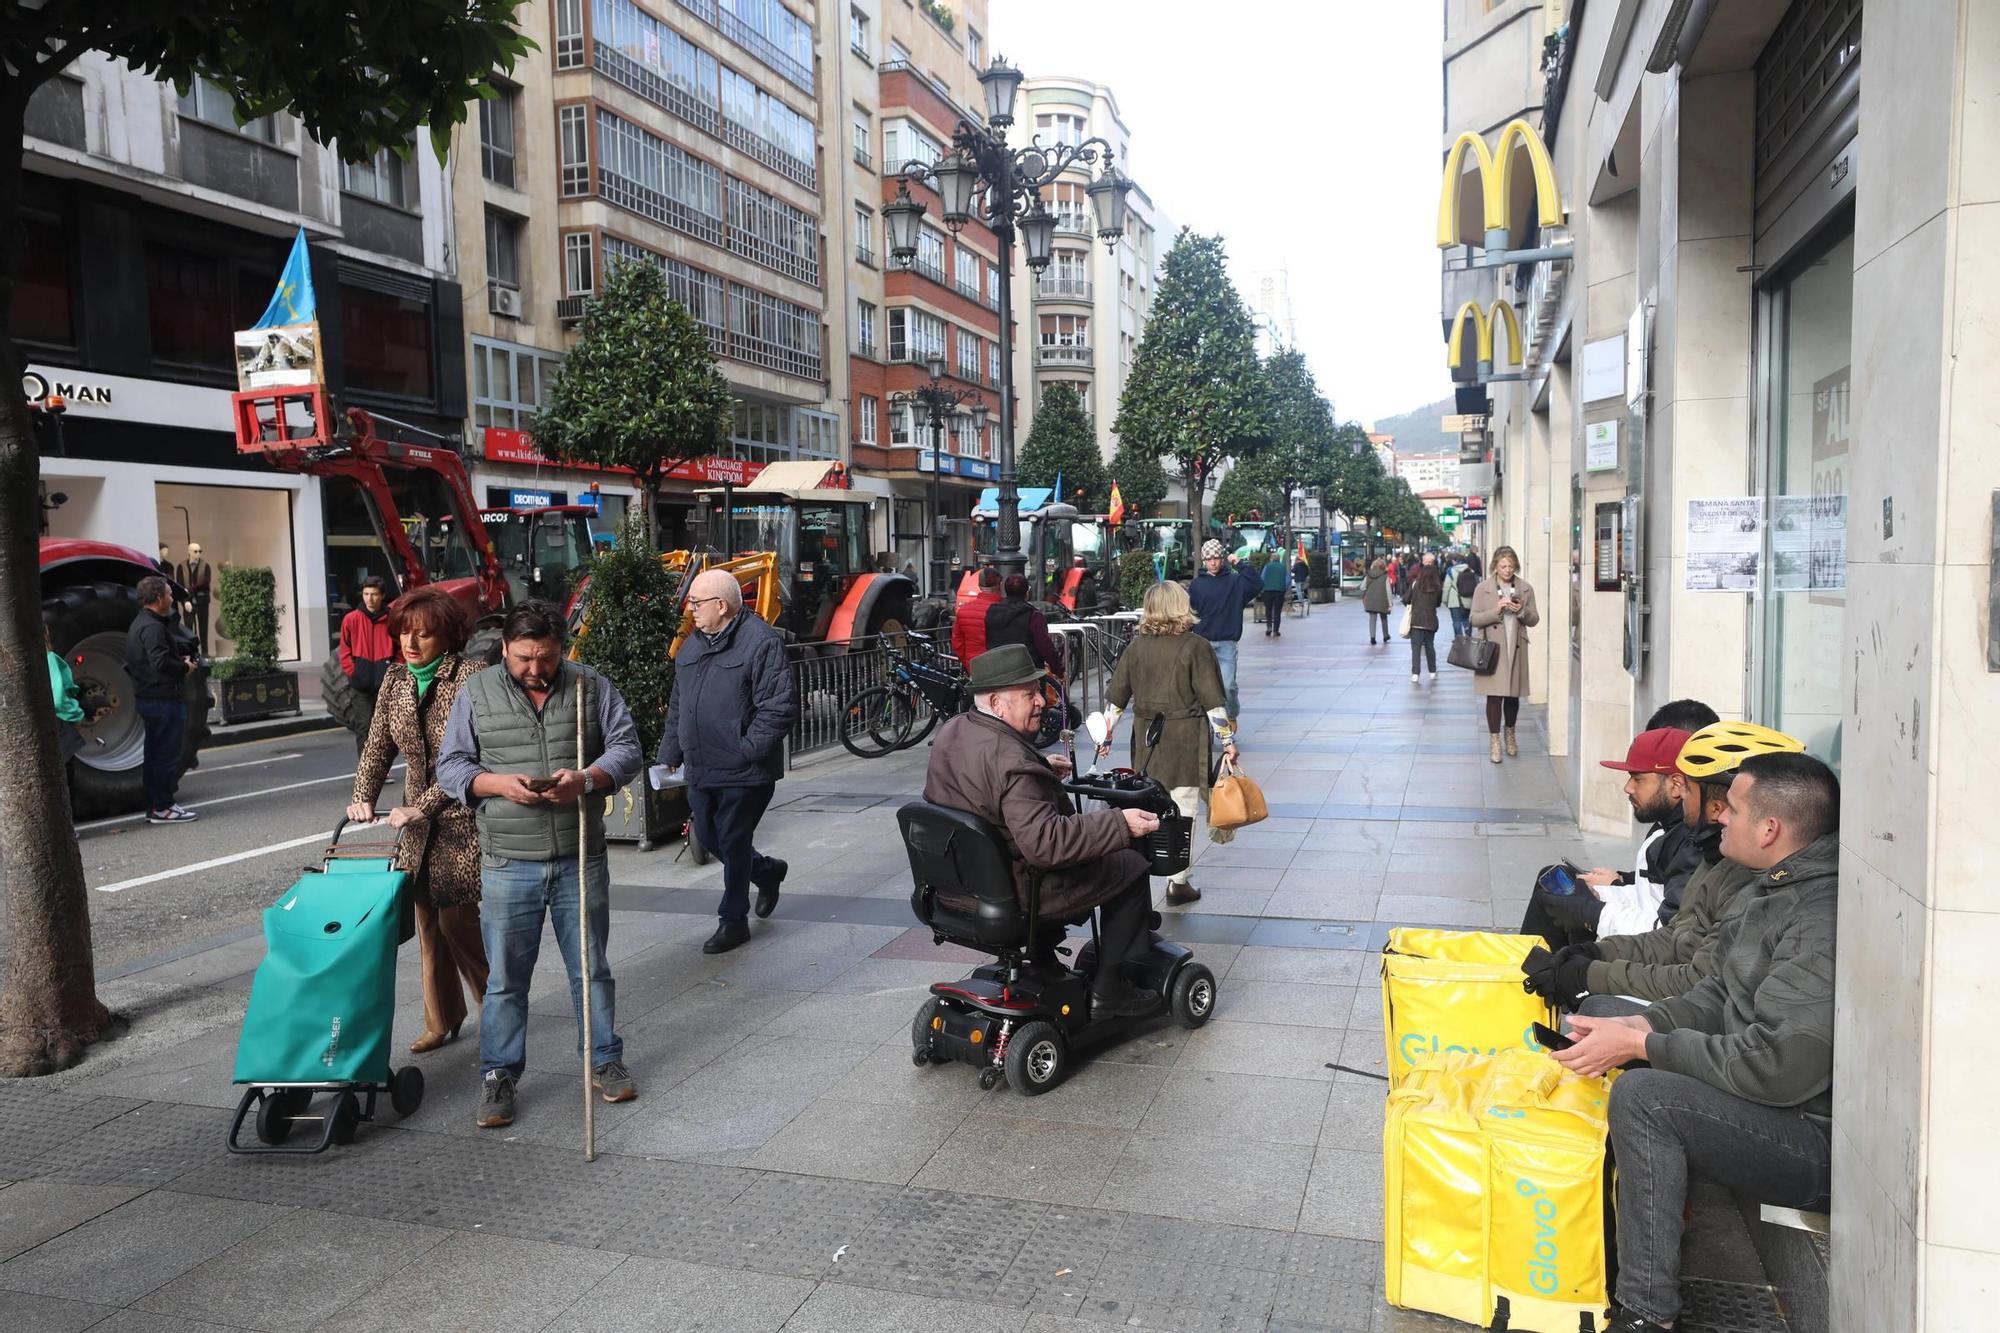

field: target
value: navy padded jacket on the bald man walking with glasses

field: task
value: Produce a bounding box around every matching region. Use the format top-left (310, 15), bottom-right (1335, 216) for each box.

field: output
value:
top-left (660, 610), bottom-right (798, 787)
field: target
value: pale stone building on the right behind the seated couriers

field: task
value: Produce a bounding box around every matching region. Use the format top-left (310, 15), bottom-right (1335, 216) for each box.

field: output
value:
top-left (1440, 0), bottom-right (2000, 1329)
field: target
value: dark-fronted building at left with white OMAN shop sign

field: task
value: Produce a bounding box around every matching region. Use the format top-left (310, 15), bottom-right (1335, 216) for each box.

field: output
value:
top-left (14, 54), bottom-right (466, 660)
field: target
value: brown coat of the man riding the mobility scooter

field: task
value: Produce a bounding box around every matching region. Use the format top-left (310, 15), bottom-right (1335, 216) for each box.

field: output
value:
top-left (924, 713), bottom-right (1146, 921)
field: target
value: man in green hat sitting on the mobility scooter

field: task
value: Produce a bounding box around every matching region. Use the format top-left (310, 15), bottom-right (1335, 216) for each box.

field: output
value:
top-left (924, 644), bottom-right (1160, 1015)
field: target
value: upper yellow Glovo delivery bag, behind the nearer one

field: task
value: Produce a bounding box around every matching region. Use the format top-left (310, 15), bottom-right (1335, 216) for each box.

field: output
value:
top-left (1382, 927), bottom-right (1560, 1087)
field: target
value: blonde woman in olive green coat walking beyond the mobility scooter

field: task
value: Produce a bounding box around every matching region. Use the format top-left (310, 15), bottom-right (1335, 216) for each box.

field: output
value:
top-left (1098, 582), bottom-right (1236, 907)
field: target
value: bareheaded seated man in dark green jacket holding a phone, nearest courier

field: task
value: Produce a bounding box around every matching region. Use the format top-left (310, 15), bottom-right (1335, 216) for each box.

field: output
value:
top-left (1554, 755), bottom-right (1840, 1333)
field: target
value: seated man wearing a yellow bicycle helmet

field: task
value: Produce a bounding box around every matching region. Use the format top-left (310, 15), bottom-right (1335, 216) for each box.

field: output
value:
top-left (1522, 723), bottom-right (1806, 1017)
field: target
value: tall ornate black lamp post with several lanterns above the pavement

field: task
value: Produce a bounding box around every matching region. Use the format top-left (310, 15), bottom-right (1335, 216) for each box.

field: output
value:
top-left (882, 56), bottom-right (1132, 574)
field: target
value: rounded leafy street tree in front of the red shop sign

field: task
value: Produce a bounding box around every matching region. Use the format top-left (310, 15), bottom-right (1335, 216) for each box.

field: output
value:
top-left (528, 262), bottom-right (736, 544)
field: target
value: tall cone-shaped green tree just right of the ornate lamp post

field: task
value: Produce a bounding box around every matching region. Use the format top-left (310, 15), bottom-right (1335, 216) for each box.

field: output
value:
top-left (1118, 228), bottom-right (1270, 534)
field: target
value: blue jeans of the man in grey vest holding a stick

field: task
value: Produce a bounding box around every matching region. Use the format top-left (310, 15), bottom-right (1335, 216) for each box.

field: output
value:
top-left (480, 857), bottom-right (624, 1079)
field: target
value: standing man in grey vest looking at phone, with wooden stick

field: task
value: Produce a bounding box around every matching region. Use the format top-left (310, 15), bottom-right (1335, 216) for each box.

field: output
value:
top-left (438, 602), bottom-right (644, 1129)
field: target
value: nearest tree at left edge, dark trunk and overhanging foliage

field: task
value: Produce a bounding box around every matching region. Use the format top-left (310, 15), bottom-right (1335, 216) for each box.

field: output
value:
top-left (0, 0), bottom-right (532, 1075)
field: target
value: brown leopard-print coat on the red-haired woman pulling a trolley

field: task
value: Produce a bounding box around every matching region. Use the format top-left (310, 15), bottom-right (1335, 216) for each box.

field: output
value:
top-left (352, 654), bottom-right (484, 907)
